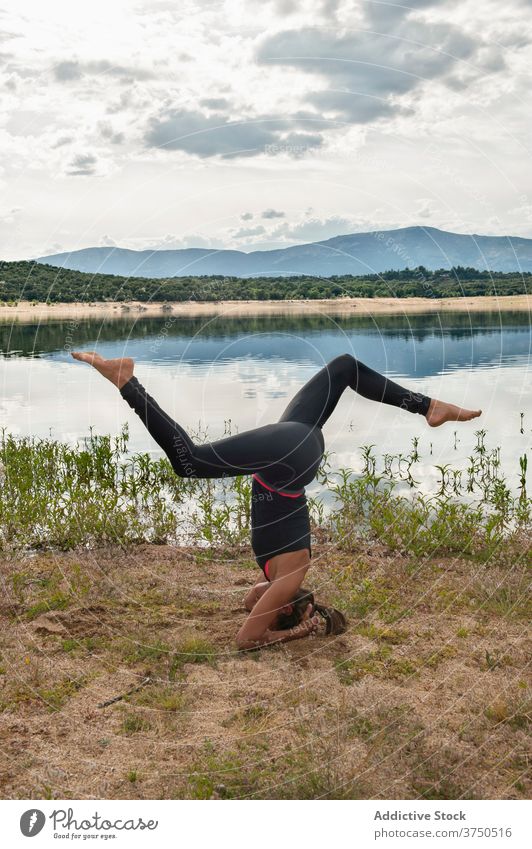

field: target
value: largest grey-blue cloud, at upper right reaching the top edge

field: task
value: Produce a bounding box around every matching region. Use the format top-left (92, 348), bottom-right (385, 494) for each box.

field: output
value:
top-left (256, 0), bottom-right (492, 124)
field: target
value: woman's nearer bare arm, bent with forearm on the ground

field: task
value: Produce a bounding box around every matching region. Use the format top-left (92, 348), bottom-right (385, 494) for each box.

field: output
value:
top-left (236, 550), bottom-right (316, 649)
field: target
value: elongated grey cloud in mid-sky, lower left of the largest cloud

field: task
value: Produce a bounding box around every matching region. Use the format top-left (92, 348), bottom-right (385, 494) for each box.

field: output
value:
top-left (144, 109), bottom-right (323, 159)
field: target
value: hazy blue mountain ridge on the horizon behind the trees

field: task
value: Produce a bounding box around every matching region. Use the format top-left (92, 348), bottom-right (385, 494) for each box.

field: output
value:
top-left (37, 227), bottom-right (532, 279)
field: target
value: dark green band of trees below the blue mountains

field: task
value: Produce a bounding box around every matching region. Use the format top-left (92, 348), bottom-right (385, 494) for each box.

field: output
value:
top-left (0, 261), bottom-right (532, 303)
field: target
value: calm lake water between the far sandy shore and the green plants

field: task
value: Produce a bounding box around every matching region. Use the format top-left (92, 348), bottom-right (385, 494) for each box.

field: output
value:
top-left (0, 312), bottom-right (532, 490)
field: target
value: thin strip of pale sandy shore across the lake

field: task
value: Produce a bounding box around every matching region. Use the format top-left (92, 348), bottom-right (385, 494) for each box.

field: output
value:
top-left (0, 295), bottom-right (532, 322)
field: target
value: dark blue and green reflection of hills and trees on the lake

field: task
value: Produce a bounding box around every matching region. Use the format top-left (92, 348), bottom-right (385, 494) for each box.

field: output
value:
top-left (0, 312), bottom-right (532, 376)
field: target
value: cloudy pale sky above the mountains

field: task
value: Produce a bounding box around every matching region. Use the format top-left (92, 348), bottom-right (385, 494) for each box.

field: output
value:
top-left (0, 0), bottom-right (532, 260)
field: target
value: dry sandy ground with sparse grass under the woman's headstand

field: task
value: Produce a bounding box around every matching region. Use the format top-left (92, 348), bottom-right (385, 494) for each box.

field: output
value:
top-left (0, 544), bottom-right (532, 799)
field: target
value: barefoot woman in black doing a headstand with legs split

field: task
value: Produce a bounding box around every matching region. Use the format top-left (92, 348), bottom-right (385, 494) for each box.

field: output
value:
top-left (72, 352), bottom-right (481, 649)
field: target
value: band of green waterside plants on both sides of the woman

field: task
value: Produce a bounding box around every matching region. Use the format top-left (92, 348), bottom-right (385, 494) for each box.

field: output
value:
top-left (0, 422), bottom-right (531, 556)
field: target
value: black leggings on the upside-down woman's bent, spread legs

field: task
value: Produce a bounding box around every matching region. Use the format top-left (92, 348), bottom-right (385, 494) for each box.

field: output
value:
top-left (120, 354), bottom-right (430, 494)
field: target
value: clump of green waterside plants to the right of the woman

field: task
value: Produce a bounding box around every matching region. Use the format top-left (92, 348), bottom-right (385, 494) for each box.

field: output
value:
top-left (328, 430), bottom-right (531, 555)
